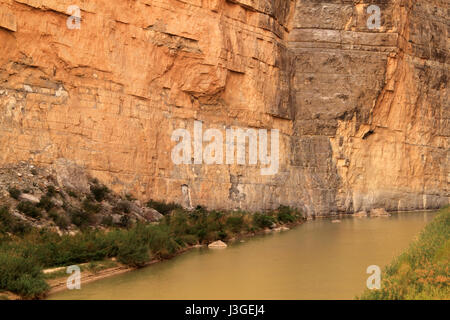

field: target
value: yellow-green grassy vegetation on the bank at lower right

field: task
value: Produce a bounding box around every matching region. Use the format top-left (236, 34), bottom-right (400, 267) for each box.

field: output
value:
top-left (359, 206), bottom-right (450, 300)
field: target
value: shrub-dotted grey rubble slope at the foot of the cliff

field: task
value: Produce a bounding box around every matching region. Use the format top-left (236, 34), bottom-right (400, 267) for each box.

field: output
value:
top-left (0, 160), bottom-right (163, 234)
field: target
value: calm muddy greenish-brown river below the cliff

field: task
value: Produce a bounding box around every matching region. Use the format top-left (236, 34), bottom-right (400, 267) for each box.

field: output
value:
top-left (49, 212), bottom-right (435, 299)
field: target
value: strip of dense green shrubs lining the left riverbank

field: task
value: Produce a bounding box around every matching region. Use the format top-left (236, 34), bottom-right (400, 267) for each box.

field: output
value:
top-left (0, 195), bottom-right (304, 299)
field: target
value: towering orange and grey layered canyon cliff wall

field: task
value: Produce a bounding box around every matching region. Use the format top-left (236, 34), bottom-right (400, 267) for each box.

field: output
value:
top-left (0, 0), bottom-right (450, 216)
